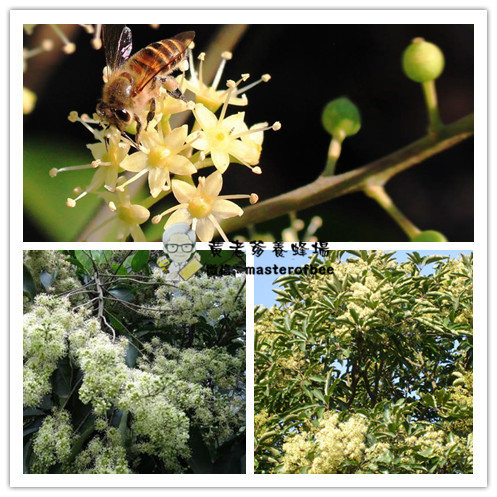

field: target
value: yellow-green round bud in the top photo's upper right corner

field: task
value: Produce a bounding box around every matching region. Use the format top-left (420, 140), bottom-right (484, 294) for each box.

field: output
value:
top-left (402, 38), bottom-right (445, 83)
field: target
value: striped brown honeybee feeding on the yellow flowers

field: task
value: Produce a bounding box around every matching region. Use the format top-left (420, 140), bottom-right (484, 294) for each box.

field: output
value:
top-left (97, 24), bottom-right (195, 142)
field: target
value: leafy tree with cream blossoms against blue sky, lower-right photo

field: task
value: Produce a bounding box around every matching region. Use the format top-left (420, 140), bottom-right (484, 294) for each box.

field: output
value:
top-left (255, 251), bottom-right (473, 473)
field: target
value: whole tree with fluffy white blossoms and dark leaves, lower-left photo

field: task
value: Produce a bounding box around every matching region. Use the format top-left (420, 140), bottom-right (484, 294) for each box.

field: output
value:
top-left (23, 251), bottom-right (245, 474)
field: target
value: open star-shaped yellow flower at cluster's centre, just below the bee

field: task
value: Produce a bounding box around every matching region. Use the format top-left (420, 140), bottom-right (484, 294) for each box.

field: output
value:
top-left (119, 124), bottom-right (197, 198)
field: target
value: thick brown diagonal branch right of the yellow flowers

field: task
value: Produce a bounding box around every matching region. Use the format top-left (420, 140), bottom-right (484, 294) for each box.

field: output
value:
top-left (221, 114), bottom-right (474, 233)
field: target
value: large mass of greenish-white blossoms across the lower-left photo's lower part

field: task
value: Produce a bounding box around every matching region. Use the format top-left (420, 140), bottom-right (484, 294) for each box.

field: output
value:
top-left (24, 295), bottom-right (245, 473)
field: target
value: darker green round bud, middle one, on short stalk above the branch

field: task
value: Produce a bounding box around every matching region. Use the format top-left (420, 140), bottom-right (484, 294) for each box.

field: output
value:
top-left (321, 97), bottom-right (361, 139)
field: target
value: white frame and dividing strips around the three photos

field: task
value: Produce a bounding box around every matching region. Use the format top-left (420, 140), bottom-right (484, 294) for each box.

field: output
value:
top-left (10, 7), bottom-right (487, 487)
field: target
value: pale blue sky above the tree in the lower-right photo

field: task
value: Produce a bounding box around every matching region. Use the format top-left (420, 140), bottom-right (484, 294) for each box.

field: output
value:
top-left (254, 250), bottom-right (471, 307)
